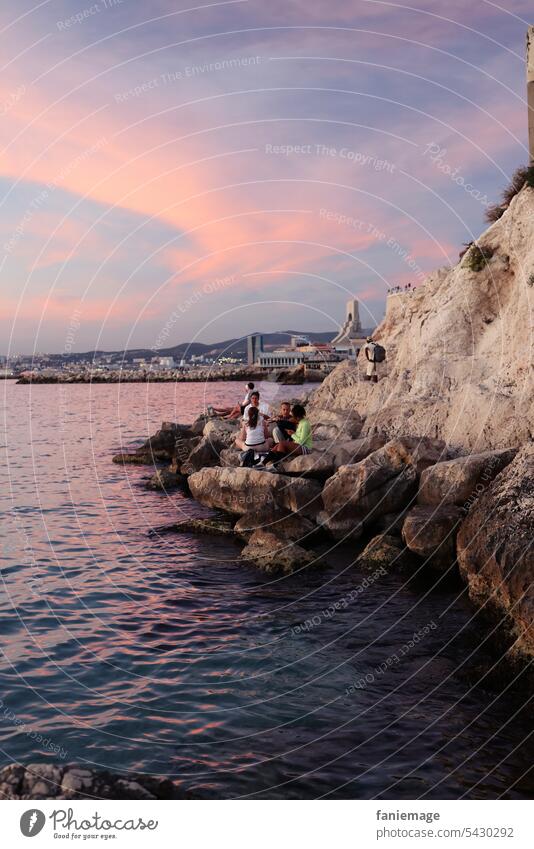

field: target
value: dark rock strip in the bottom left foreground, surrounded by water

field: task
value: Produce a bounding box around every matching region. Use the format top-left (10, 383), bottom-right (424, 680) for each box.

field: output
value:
top-left (0, 763), bottom-right (194, 800)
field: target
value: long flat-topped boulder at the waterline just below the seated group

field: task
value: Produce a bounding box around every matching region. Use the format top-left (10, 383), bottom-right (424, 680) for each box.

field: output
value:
top-left (189, 466), bottom-right (321, 518)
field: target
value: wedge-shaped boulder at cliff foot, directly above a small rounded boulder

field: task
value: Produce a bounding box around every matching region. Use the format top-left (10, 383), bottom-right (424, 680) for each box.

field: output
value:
top-left (417, 449), bottom-right (516, 509)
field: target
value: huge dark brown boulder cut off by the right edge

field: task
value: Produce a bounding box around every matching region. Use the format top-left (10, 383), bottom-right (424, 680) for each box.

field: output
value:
top-left (457, 442), bottom-right (534, 658)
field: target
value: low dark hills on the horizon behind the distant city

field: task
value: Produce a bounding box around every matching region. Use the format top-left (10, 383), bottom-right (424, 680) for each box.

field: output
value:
top-left (45, 330), bottom-right (372, 362)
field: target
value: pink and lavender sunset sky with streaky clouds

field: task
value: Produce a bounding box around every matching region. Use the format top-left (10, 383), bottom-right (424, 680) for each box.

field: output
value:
top-left (0, 0), bottom-right (534, 354)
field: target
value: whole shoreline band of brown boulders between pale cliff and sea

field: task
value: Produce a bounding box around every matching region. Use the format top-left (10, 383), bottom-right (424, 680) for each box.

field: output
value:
top-left (113, 396), bottom-right (534, 668)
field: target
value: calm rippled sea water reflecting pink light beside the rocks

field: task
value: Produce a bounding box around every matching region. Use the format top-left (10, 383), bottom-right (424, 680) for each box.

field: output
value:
top-left (0, 382), bottom-right (532, 798)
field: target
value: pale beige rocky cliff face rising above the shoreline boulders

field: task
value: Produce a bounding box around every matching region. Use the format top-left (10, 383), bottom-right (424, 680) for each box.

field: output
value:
top-left (311, 187), bottom-right (534, 453)
